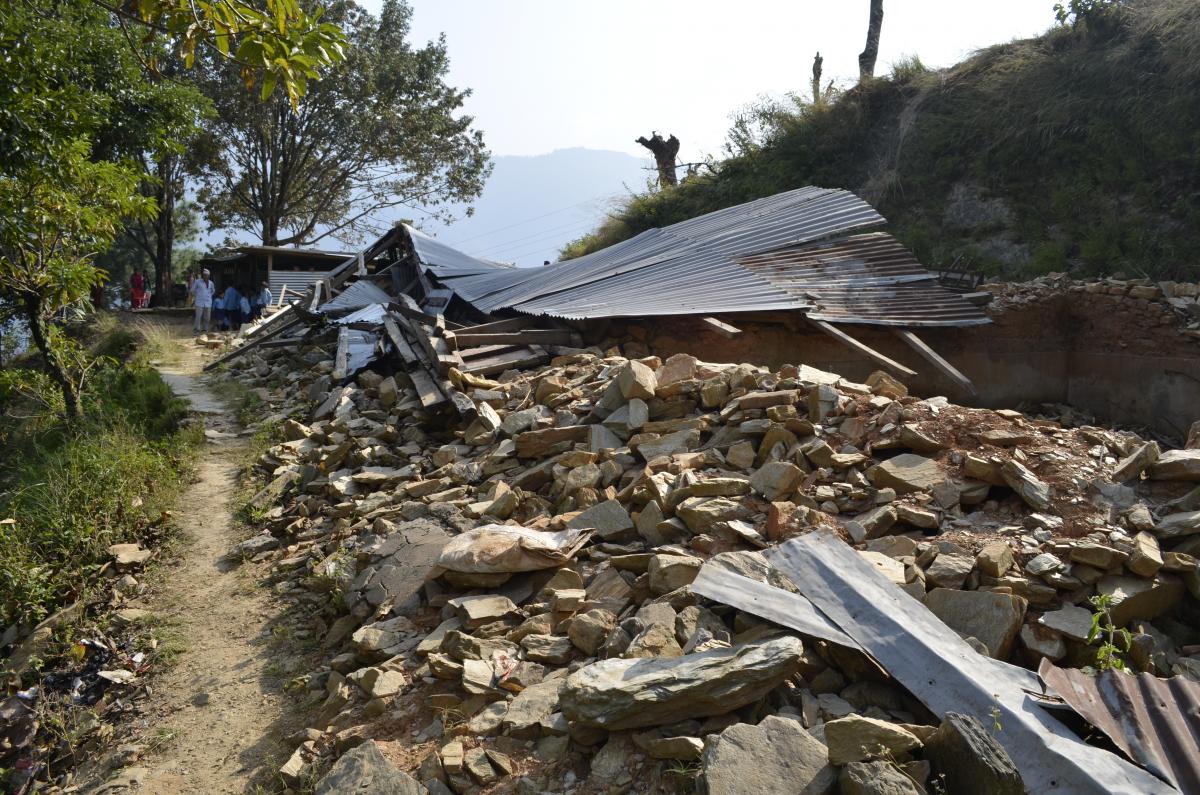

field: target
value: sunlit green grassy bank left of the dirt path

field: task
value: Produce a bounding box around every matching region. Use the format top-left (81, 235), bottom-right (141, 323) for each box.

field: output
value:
top-left (0, 316), bottom-right (203, 665)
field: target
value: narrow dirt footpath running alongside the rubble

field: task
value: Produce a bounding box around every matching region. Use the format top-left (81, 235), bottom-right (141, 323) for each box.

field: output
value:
top-left (109, 326), bottom-right (300, 795)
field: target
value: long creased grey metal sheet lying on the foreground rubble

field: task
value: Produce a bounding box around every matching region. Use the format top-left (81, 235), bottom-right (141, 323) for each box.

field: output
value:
top-left (763, 532), bottom-right (1177, 795)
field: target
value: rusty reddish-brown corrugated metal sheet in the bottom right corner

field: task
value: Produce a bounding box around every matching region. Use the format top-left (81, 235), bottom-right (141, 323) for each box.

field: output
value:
top-left (1038, 659), bottom-right (1200, 793)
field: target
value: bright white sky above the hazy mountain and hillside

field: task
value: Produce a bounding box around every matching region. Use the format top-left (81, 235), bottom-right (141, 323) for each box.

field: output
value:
top-left (360, 0), bottom-right (1054, 161)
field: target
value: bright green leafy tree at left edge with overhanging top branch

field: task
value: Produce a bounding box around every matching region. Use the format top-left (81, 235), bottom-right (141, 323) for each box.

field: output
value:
top-left (0, 0), bottom-right (343, 419)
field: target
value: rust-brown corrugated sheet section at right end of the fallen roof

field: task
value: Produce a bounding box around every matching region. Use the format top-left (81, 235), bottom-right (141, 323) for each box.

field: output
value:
top-left (738, 232), bottom-right (989, 327)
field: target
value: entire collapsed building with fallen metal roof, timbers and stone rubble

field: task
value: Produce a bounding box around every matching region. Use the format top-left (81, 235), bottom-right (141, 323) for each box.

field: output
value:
top-left (206, 189), bottom-right (1200, 793)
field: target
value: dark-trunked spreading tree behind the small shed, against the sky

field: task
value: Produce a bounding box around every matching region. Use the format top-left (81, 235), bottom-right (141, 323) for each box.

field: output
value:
top-left (199, 0), bottom-right (490, 245)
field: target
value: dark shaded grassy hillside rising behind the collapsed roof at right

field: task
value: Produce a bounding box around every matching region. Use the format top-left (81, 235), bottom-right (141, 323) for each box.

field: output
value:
top-left (563, 0), bottom-right (1200, 279)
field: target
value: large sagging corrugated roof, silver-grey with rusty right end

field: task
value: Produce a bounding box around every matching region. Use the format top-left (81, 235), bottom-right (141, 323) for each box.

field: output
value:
top-left (409, 187), bottom-right (988, 325)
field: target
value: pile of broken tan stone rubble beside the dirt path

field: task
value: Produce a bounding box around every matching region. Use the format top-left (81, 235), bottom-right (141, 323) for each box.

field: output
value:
top-left (221, 338), bottom-right (1200, 793)
